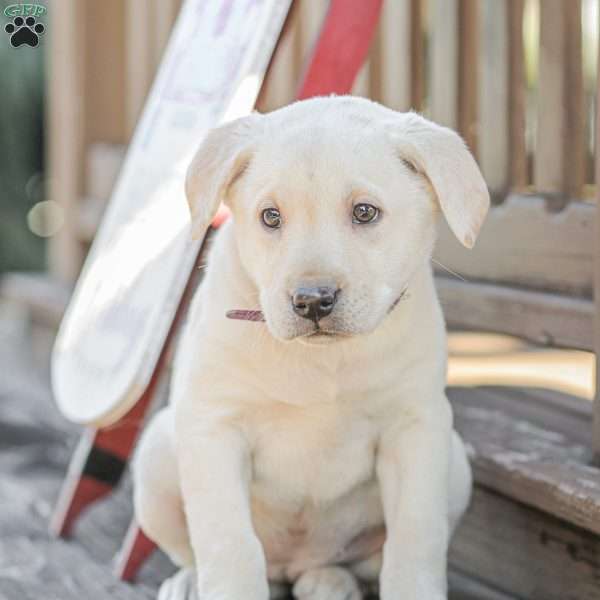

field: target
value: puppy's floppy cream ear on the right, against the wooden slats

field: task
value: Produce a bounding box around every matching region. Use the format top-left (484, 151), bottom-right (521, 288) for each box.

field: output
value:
top-left (390, 113), bottom-right (490, 248)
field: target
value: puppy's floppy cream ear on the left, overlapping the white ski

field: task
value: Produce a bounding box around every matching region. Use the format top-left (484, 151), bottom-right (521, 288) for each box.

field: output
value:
top-left (185, 113), bottom-right (261, 239)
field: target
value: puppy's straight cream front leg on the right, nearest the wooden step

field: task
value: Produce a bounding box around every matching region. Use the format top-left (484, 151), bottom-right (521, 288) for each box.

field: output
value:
top-left (377, 397), bottom-right (452, 600)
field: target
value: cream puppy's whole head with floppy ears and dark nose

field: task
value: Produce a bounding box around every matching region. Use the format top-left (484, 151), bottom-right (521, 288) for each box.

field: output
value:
top-left (186, 97), bottom-right (489, 343)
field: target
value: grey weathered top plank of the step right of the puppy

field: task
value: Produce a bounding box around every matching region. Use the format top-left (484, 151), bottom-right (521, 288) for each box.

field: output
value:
top-left (450, 389), bottom-right (600, 540)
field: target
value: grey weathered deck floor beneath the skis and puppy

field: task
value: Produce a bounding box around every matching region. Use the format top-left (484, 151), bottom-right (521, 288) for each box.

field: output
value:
top-left (0, 315), bottom-right (504, 600)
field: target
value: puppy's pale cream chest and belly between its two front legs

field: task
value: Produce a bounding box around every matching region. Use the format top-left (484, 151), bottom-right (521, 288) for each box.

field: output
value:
top-left (252, 404), bottom-right (383, 579)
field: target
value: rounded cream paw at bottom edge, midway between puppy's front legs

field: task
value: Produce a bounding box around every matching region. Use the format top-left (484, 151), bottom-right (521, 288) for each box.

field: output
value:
top-left (292, 567), bottom-right (363, 600)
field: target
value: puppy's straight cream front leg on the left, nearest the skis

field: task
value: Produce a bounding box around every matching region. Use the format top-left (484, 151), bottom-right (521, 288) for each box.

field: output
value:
top-left (177, 411), bottom-right (269, 600)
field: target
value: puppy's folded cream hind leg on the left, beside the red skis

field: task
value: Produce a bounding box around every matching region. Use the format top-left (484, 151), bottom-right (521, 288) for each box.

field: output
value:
top-left (133, 407), bottom-right (194, 566)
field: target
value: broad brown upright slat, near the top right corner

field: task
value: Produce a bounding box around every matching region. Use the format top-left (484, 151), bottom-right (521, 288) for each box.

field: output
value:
top-left (534, 0), bottom-right (585, 201)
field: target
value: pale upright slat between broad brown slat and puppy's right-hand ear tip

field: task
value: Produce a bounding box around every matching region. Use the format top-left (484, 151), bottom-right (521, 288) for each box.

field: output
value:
top-left (478, 0), bottom-right (510, 193)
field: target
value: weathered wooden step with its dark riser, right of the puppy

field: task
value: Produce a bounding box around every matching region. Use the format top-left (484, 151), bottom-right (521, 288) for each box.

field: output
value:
top-left (448, 388), bottom-right (600, 600)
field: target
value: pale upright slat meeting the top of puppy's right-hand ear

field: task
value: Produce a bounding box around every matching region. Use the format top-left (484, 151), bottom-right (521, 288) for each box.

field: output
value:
top-left (426, 0), bottom-right (459, 129)
